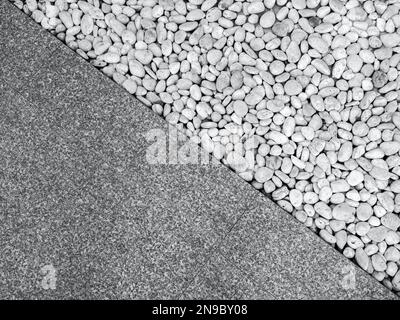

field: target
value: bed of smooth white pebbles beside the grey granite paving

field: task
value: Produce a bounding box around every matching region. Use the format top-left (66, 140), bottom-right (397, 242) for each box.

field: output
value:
top-left (13, 0), bottom-right (400, 295)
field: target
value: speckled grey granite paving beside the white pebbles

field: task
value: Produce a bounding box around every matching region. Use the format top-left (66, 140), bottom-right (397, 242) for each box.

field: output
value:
top-left (0, 0), bottom-right (396, 299)
